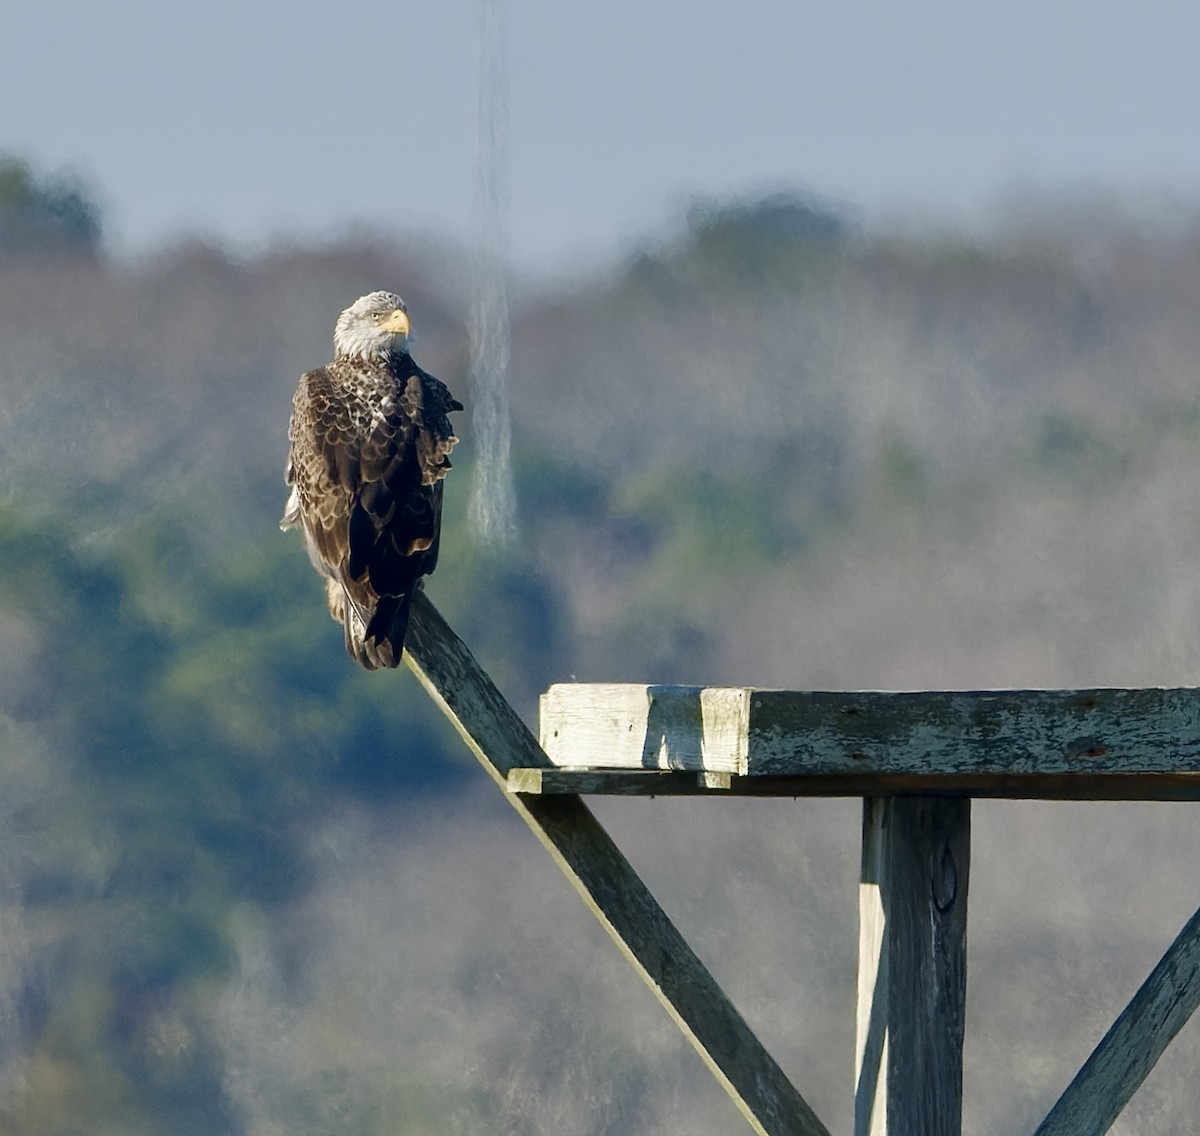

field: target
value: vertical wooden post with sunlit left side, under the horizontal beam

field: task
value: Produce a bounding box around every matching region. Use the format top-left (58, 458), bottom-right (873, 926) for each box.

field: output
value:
top-left (854, 797), bottom-right (971, 1136)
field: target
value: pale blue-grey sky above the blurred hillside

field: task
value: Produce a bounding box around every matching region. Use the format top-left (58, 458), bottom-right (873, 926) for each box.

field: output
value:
top-left (0, 0), bottom-right (1200, 268)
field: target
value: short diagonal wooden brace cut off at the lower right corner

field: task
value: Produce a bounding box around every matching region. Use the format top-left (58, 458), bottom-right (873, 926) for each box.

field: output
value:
top-left (1036, 910), bottom-right (1200, 1136)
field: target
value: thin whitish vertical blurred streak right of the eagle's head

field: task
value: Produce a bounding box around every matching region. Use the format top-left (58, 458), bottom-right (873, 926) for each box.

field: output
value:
top-left (469, 0), bottom-right (516, 549)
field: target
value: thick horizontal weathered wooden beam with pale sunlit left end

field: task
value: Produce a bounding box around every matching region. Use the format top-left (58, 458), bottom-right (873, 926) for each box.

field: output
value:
top-left (541, 684), bottom-right (1200, 777)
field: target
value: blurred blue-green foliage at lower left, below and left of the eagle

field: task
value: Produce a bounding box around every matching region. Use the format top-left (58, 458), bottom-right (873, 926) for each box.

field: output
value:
top-left (0, 484), bottom-right (472, 1136)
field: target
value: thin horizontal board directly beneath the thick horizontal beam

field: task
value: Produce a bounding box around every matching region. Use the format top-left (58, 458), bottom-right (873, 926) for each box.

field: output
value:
top-left (508, 769), bottom-right (1200, 801)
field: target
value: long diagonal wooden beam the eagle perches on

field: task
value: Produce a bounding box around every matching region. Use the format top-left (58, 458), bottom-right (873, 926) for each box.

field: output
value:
top-left (404, 593), bottom-right (829, 1136)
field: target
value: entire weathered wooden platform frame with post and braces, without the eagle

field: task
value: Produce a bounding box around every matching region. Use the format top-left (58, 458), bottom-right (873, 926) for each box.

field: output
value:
top-left (404, 593), bottom-right (1200, 1136)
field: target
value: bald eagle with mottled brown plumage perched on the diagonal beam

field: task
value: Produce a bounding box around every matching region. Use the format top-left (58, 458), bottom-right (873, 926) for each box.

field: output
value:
top-left (280, 291), bottom-right (462, 671)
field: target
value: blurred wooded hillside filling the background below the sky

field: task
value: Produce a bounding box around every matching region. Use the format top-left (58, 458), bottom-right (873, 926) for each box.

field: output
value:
top-left (0, 187), bottom-right (1200, 1136)
